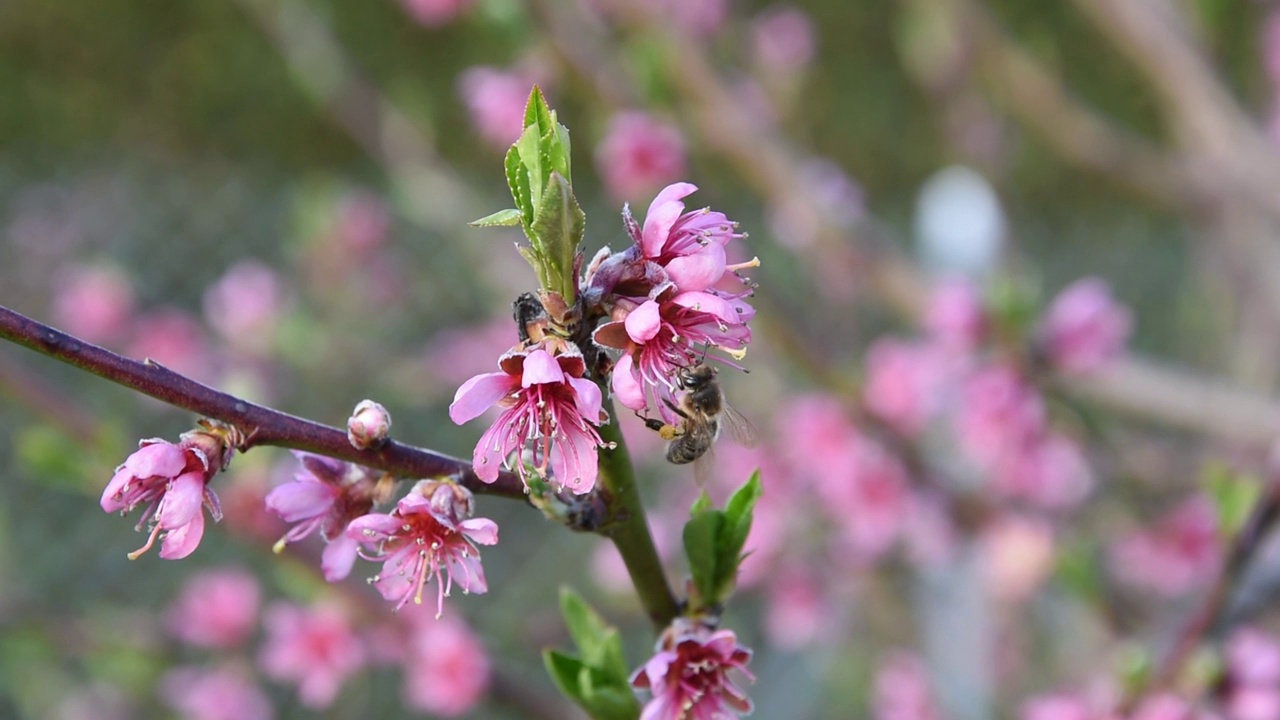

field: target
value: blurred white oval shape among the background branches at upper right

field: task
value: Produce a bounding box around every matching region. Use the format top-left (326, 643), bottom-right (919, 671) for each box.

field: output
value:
top-left (915, 165), bottom-right (1005, 278)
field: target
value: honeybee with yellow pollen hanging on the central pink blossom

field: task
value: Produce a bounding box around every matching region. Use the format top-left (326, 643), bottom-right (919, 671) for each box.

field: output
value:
top-left (644, 361), bottom-right (758, 486)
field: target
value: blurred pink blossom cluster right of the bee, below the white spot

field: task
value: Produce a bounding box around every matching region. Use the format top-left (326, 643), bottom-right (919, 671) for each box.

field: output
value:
top-left (864, 278), bottom-right (1130, 509)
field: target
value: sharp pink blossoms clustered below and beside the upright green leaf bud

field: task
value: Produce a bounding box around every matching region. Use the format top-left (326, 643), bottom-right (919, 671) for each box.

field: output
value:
top-left (449, 183), bottom-right (756, 495)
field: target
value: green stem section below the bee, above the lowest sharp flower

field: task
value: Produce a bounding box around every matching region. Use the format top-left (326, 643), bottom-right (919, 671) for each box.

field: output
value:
top-left (599, 401), bottom-right (680, 630)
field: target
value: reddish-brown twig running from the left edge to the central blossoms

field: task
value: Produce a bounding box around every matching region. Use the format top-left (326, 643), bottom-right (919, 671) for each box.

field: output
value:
top-left (0, 306), bottom-right (526, 500)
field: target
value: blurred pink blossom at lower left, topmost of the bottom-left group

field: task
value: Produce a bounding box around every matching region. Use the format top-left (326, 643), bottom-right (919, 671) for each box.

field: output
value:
top-left (165, 568), bottom-right (261, 648)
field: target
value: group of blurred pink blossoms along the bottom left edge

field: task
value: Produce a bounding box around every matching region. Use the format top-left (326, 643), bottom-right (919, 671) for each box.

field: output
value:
top-left (148, 568), bottom-right (490, 720)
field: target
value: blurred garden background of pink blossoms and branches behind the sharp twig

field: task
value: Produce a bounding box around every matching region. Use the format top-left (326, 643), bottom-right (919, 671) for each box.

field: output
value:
top-left (0, 0), bottom-right (1280, 720)
